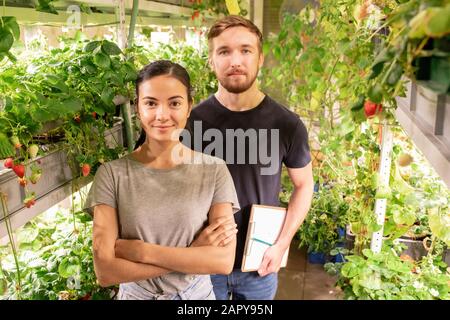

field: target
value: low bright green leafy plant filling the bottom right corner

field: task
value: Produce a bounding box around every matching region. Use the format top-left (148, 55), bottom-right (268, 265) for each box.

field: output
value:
top-left (326, 246), bottom-right (450, 300)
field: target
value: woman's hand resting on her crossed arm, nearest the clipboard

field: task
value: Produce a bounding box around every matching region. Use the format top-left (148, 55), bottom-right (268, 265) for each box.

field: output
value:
top-left (191, 216), bottom-right (238, 247)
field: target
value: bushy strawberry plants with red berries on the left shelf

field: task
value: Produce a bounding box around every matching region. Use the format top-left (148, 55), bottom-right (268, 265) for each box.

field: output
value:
top-left (0, 34), bottom-right (136, 198)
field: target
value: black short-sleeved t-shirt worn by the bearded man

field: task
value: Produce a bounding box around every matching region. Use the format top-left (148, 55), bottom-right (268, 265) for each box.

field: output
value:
top-left (183, 95), bottom-right (311, 268)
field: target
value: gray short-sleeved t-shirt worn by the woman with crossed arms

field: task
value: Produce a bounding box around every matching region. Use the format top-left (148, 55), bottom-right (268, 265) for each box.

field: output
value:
top-left (85, 152), bottom-right (239, 294)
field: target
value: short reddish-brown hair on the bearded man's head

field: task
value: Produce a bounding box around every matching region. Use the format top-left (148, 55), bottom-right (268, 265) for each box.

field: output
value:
top-left (208, 15), bottom-right (263, 54)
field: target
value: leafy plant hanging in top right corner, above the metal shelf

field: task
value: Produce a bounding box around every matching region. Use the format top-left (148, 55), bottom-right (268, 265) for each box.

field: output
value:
top-left (368, 0), bottom-right (450, 99)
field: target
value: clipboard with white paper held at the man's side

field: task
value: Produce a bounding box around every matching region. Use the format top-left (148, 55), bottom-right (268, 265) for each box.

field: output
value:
top-left (241, 204), bottom-right (289, 272)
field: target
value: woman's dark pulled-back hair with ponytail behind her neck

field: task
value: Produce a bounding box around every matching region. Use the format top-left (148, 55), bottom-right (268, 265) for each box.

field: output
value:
top-left (134, 60), bottom-right (193, 150)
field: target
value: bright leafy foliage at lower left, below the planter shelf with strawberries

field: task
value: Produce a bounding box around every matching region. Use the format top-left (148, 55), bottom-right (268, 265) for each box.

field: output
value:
top-left (0, 205), bottom-right (115, 300)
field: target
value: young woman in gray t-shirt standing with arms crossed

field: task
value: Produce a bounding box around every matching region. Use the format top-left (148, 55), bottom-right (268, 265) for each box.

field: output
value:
top-left (85, 61), bottom-right (239, 300)
